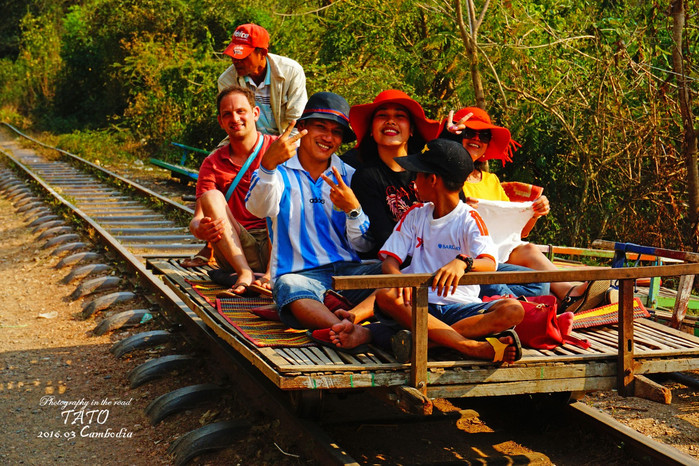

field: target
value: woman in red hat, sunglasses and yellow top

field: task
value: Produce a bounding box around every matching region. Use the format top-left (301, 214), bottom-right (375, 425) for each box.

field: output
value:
top-left (442, 107), bottom-right (609, 312)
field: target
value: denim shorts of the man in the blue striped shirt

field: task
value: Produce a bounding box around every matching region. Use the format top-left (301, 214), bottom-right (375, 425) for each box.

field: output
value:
top-left (272, 262), bottom-right (381, 328)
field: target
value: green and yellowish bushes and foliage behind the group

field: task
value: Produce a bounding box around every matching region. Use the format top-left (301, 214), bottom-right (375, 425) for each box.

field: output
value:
top-left (0, 0), bottom-right (699, 248)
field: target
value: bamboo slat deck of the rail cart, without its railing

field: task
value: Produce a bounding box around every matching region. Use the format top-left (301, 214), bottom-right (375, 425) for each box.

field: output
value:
top-left (148, 259), bottom-right (699, 397)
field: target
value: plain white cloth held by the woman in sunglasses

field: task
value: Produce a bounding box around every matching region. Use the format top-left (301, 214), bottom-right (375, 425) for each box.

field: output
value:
top-left (476, 199), bottom-right (534, 264)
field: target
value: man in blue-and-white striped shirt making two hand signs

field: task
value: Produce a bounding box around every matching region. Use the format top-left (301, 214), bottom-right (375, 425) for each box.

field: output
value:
top-left (246, 92), bottom-right (381, 329)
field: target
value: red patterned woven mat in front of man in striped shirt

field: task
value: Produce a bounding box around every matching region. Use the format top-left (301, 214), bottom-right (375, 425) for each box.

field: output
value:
top-left (216, 298), bottom-right (314, 347)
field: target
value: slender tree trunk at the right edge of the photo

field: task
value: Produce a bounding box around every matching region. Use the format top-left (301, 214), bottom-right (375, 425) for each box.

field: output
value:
top-left (670, 0), bottom-right (699, 251)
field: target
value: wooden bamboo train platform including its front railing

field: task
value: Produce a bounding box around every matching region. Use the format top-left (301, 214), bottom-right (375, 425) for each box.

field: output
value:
top-left (148, 253), bottom-right (699, 413)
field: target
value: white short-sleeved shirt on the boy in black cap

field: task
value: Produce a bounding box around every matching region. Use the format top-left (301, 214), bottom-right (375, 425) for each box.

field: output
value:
top-left (379, 202), bottom-right (496, 304)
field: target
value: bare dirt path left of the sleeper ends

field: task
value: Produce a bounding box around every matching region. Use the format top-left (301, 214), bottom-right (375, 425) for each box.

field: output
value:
top-left (0, 187), bottom-right (172, 464)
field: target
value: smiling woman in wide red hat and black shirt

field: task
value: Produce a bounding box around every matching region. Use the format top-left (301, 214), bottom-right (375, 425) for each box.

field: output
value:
top-left (349, 89), bottom-right (440, 258)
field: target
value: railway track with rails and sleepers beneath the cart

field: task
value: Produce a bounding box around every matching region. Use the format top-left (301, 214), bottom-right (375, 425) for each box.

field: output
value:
top-left (0, 126), bottom-right (694, 464)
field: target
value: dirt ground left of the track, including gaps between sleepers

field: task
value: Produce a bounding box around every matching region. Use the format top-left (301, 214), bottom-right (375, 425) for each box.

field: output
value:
top-left (0, 166), bottom-right (303, 465)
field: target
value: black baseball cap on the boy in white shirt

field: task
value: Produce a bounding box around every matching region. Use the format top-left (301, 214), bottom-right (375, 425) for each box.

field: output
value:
top-left (394, 139), bottom-right (473, 183)
